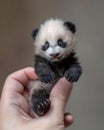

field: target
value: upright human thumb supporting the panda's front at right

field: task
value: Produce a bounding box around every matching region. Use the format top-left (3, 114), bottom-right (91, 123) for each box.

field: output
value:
top-left (50, 78), bottom-right (72, 115)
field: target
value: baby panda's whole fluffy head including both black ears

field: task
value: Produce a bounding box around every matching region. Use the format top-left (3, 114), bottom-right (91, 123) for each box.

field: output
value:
top-left (32, 19), bottom-right (76, 61)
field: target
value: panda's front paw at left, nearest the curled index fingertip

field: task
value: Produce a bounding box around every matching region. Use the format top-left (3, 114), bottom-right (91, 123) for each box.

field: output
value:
top-left (40, 72), bottom-right (56, 83)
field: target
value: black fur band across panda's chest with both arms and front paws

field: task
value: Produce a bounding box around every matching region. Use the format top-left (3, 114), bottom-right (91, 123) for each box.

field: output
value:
top-left (35, 52), bottom-right (81, 83)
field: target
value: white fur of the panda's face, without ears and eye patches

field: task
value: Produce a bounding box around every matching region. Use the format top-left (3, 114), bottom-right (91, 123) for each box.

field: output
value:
top-left (34, 19), bottom-right (74, 60)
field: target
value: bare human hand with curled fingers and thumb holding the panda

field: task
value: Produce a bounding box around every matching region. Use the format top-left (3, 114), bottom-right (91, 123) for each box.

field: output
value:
top-left (0, 67), bottom-right (73, 130)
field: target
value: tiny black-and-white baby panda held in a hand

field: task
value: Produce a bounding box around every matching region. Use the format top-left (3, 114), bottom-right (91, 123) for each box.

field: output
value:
top-left (28, 19), bottom-right (82, 116)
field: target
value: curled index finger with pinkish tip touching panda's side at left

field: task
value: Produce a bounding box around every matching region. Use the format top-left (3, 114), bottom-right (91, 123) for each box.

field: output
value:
top-left (2, 67), bottom-right (37, 95)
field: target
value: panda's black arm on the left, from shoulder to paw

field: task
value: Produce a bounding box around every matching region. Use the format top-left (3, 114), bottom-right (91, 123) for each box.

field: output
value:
top-left (35, 55), bottom-right (55, 83)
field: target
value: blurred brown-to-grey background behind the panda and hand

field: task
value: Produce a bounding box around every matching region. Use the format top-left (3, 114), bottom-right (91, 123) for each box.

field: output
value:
top-left (0, 0), bottom-right (104, 130)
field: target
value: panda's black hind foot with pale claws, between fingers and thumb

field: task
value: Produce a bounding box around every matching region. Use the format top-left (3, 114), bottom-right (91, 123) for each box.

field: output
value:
top-left (31, 89), bottom-right (51, 116)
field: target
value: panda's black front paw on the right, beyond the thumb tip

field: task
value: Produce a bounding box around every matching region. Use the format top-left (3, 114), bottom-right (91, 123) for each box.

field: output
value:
top-left (64, 67), bottom-right (82, 82)
